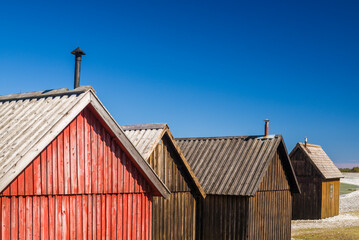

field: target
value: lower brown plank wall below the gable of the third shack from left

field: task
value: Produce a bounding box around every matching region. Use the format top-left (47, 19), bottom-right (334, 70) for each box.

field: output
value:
top-left (248, 191), bottom-right (292, 240)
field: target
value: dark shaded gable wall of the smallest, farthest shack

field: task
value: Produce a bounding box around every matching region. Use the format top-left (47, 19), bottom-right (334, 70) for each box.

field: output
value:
top-left (291, 149), bottom-right (322, 220)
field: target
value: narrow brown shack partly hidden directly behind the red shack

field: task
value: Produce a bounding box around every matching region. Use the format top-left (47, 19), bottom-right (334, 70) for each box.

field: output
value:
top-left (122, 123), bottom-right (205, 240)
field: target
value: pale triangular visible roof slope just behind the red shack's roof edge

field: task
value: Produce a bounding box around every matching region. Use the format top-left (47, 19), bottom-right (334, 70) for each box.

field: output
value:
top-left (121, 123), bottom-right (167, 159)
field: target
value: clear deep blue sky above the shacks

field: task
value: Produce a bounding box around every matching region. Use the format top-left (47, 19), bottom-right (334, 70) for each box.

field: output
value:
top-left (0, 0), bottom-right (359, 163)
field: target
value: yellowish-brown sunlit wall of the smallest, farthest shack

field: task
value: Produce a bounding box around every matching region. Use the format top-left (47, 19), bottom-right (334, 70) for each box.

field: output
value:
top-left (321, 179), bottom-right (340, 218)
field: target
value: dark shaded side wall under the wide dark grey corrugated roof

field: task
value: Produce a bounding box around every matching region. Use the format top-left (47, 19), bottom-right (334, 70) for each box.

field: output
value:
top-left (196, 195), bottom-right (249, 240)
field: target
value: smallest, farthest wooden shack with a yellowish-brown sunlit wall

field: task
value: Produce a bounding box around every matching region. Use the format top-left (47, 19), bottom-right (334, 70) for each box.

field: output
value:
top-left (290, 143), bottom-right (343, 219)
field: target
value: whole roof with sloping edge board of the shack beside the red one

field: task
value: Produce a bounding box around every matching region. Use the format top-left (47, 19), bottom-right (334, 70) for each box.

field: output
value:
top-left (121, 123), bottom-right (206, 197)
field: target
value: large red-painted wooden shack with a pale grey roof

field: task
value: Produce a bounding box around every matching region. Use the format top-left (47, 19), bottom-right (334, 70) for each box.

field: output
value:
top-left (0, 87), bottom-right (169, 239)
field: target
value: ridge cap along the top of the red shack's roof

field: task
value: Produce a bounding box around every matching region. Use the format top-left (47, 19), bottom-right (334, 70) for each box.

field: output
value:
top-left (0, 86), bottom-right (96, 101)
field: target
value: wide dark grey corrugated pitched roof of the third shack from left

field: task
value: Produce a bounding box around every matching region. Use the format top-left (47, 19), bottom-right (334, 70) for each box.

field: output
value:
top-left (176, 135), bottom-right (299, 196)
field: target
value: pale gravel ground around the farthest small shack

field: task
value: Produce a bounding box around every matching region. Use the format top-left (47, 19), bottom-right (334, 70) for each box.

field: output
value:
top-left (292, 173), bottom-right (359, 231)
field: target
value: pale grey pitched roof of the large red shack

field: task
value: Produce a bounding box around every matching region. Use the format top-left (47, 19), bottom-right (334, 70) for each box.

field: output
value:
top-left (0, 86), bottom-right (170, 197)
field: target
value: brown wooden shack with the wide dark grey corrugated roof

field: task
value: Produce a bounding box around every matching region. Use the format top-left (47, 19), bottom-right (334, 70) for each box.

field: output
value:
top-left (176, 135), bottom-right (300, 240)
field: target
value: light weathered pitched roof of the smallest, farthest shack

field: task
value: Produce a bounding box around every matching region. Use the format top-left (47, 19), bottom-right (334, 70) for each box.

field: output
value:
top-left (290, 143), bottom-right (344, 179)
